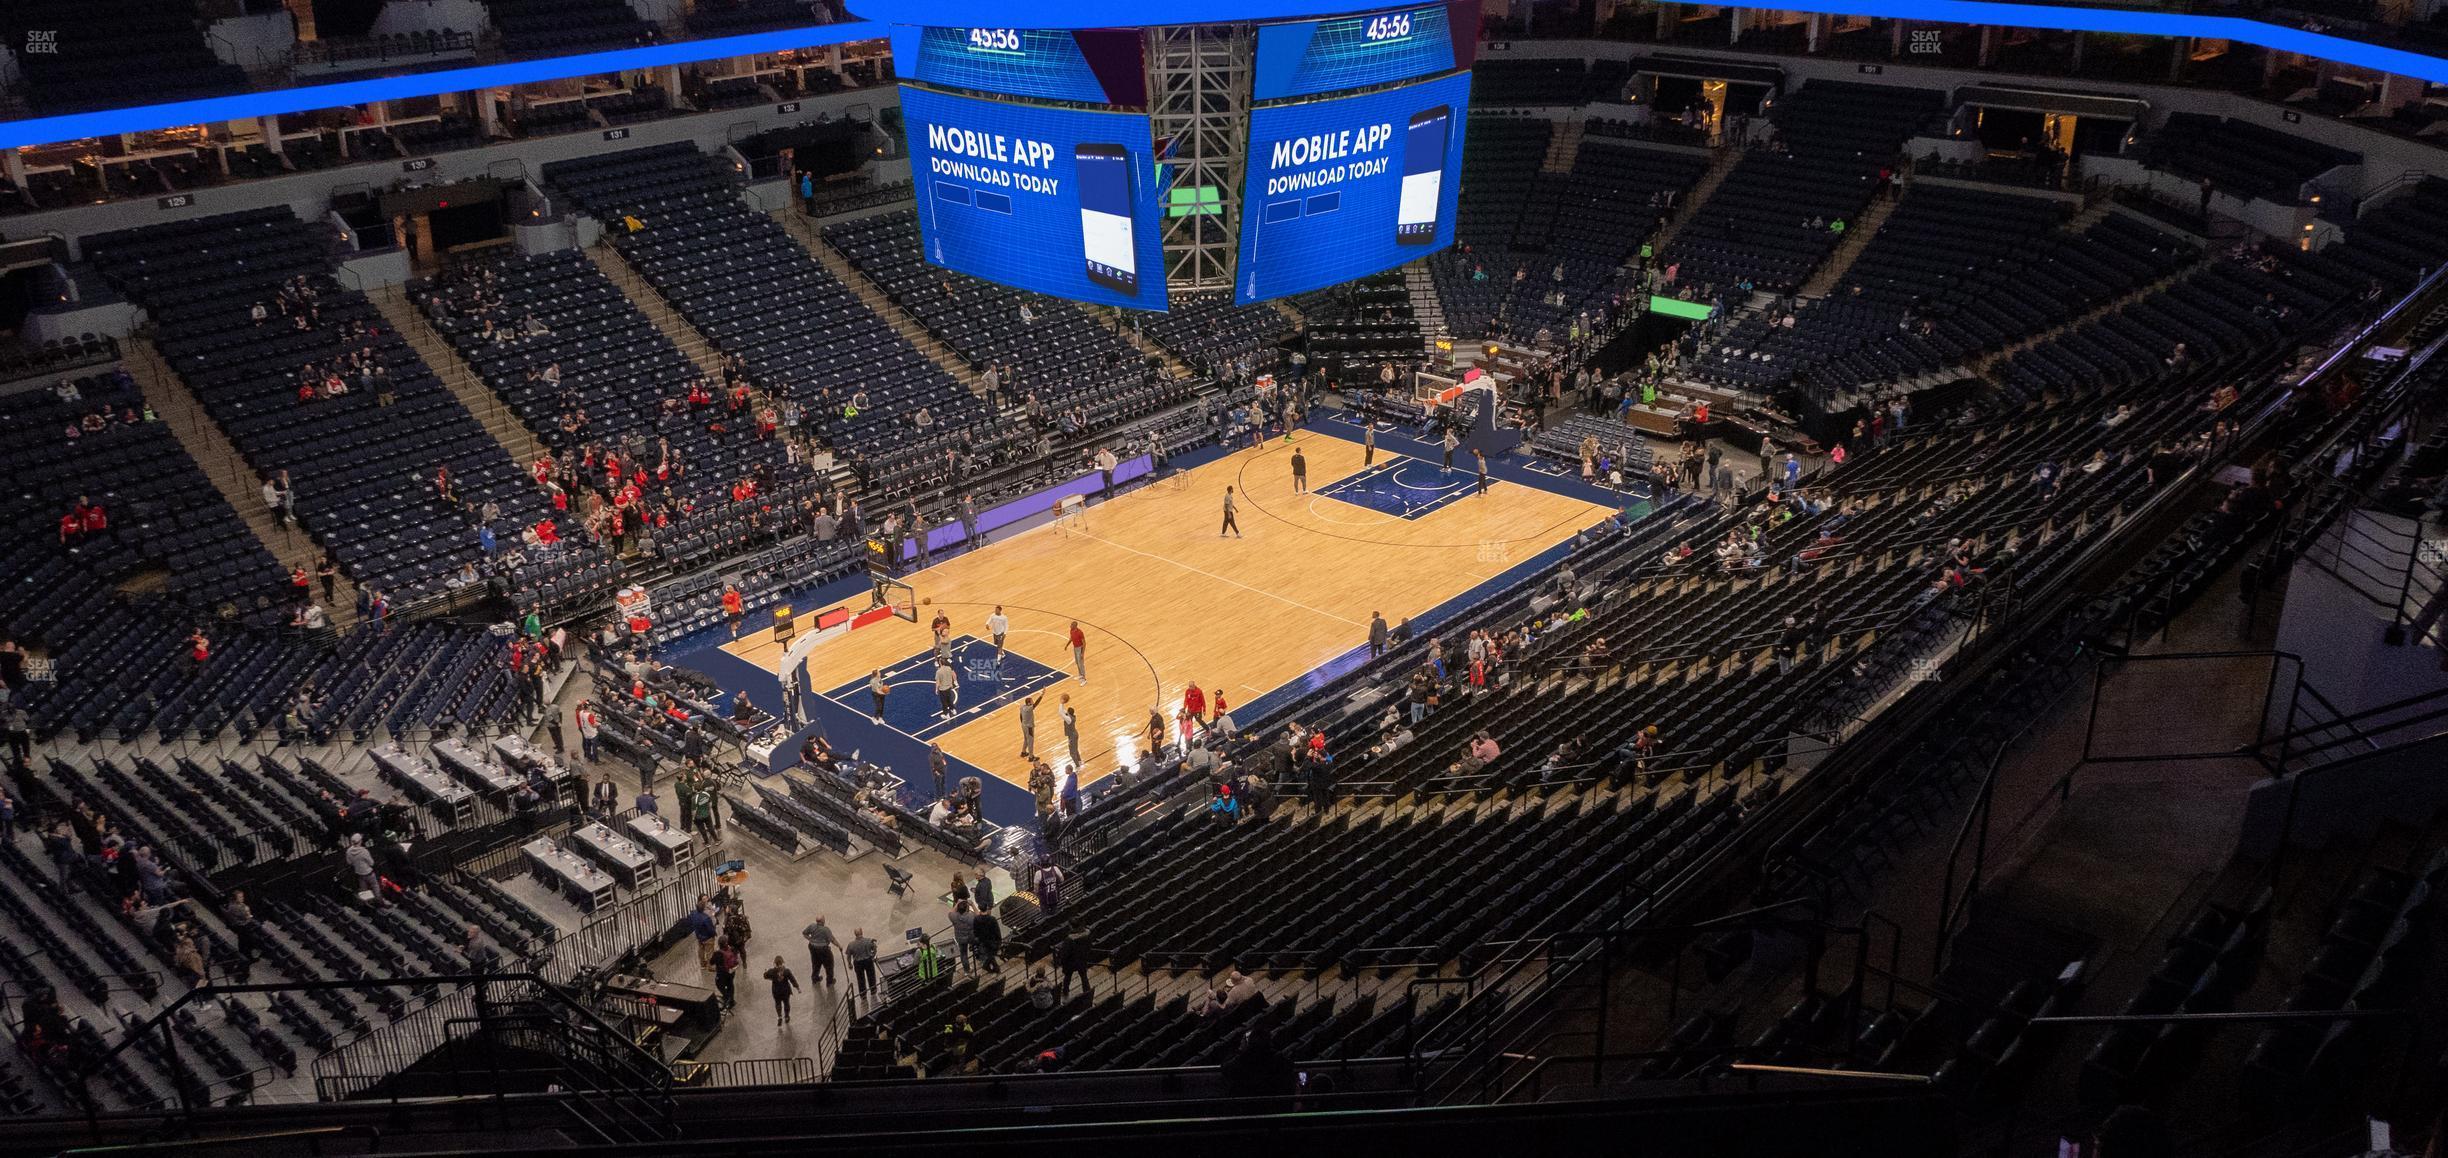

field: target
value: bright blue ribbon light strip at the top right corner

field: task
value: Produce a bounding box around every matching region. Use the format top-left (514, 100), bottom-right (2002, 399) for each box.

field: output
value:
top-left (1667, 0), bottom-right (2448, 83)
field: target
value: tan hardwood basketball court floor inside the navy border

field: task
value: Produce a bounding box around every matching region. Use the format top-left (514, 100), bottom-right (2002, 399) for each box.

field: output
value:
top-left (725, 431), bottom-right (1613, 786)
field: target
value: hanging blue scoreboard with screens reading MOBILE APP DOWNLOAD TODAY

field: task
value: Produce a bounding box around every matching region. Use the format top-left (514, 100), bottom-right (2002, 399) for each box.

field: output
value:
top-left (852, 0), bottom-right (1479, 311)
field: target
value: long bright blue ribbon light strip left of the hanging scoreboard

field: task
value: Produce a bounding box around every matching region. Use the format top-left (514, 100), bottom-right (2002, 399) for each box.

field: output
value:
top-left (0, 22), bottom-right (884, 149)
